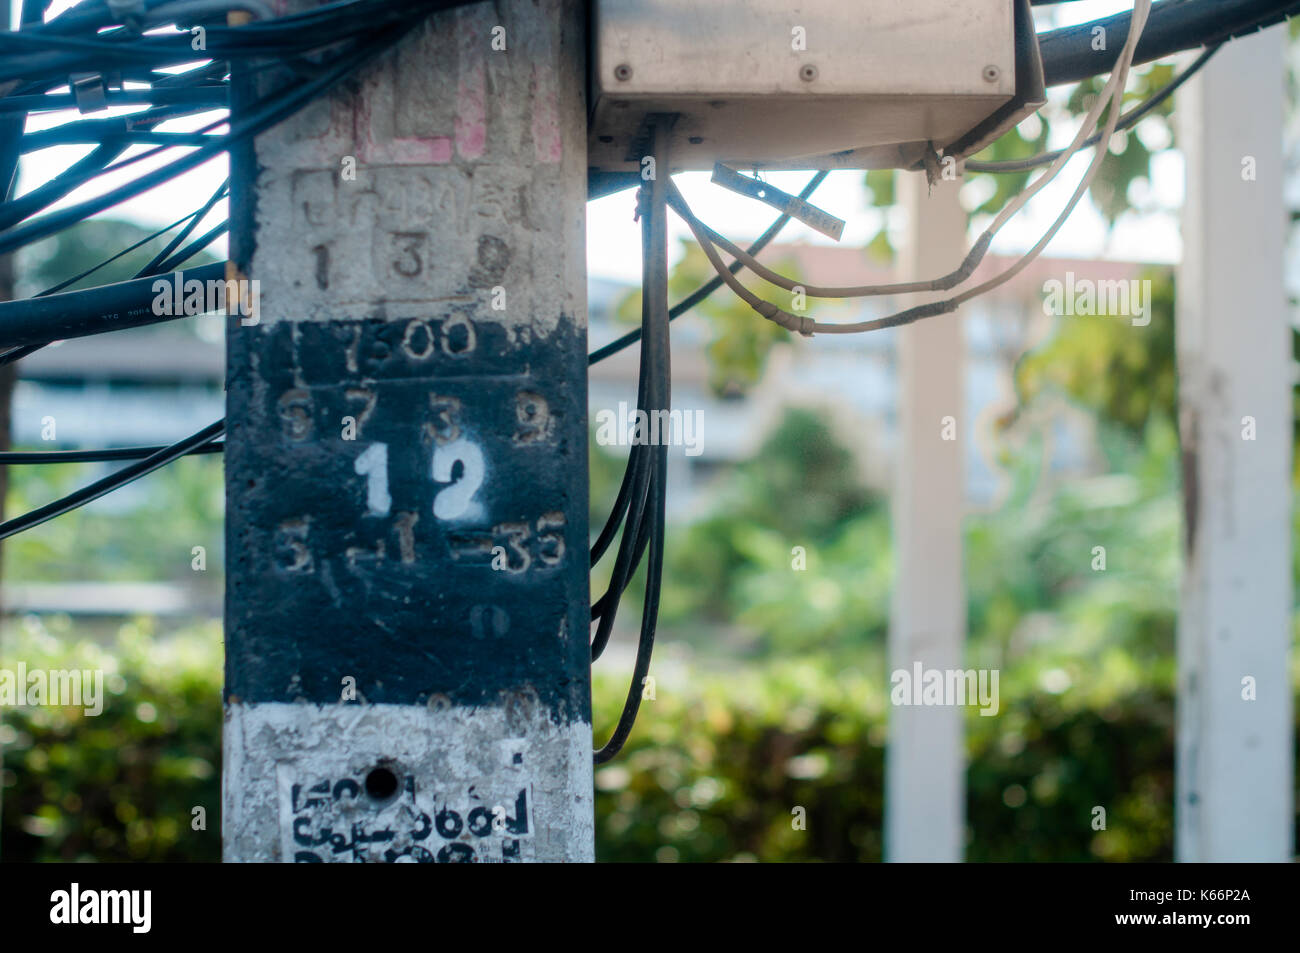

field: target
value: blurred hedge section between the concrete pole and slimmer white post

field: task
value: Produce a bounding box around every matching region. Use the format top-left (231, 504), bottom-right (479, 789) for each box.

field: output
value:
top-left (594, 664), bottom-right (885, 862)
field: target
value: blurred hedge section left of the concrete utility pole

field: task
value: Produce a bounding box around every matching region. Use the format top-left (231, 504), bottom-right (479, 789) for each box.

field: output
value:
top-left (0, 618), bottom-right (221, 861)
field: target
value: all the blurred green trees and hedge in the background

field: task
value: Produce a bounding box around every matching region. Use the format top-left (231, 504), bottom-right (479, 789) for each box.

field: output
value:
top-left (0, 46), bottom-right (1300, 862)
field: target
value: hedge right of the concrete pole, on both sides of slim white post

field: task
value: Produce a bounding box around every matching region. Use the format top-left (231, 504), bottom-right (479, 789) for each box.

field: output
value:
top-left (594, 651), bottom-right (1274, 862)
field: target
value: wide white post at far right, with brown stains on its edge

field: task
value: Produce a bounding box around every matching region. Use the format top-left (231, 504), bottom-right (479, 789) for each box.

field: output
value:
top-left (1175, 29), bottom-right (1294, 862)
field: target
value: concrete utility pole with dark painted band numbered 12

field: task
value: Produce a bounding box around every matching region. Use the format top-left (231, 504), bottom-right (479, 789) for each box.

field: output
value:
top-left (222, 0), bottom-right (593, 862)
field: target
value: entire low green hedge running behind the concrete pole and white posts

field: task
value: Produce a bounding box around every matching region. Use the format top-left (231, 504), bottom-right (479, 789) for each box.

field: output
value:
top-left (0, 625), bottom-right (1268, 862)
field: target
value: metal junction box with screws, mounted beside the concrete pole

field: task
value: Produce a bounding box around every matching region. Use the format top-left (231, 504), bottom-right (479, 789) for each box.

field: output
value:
top-left (589, 0), bottom-right (1045, 172)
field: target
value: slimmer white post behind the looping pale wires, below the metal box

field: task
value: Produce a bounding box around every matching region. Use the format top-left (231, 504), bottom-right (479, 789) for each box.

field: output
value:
top-left (884, 173), bottom-right (969, 862)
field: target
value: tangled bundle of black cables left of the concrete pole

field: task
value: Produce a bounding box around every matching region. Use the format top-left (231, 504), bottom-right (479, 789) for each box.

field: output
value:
top-left (0, 0), bottom-right (473, 540)
